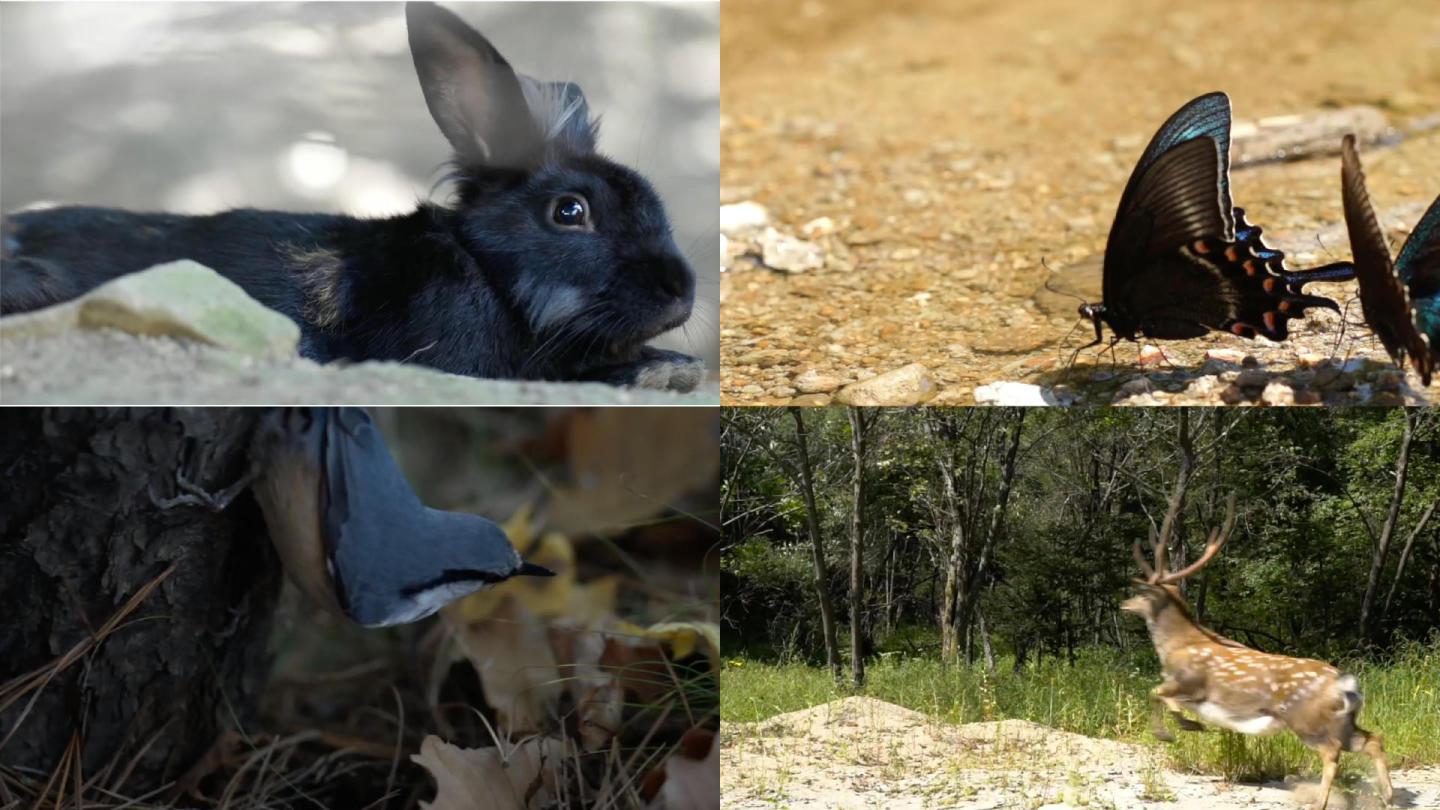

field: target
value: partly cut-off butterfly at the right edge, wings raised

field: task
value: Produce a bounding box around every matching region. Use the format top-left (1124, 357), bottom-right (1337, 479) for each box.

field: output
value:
top-left (1341, 135), bottom-right (1440, 385)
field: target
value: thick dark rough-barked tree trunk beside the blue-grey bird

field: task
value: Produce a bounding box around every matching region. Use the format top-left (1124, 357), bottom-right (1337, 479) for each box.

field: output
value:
top-left (0, 408), bottom-right (281, 796)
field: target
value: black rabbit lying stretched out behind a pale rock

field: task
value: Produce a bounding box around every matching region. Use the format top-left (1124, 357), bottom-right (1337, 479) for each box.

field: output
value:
top-left (0, 3), bottom-right (700, 389)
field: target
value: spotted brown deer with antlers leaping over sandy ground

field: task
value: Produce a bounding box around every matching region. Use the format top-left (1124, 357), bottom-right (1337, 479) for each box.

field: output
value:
top-left (1120, 494), bottom-right (1392, 810)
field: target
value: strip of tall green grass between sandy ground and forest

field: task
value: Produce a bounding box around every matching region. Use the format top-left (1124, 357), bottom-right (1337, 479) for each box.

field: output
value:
top-left (720, 643), bottom-right (1440, 780)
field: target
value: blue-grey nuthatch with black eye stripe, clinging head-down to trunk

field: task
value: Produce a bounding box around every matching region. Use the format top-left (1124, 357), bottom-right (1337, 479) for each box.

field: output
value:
top-left (252, 408), bottom-right (553, 627)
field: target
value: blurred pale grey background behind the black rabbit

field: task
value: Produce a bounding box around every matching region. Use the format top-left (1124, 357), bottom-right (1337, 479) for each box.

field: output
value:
top-left (0, 3), bottom-right (720, 368)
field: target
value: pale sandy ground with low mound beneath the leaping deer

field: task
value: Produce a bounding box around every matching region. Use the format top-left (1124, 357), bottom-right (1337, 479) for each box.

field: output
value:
top-left (720, 698), bottom-right (1440, 810)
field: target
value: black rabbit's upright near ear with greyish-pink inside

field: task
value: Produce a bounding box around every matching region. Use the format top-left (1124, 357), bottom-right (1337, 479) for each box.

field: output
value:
top-left (405, 3), bottom-right (544, 169)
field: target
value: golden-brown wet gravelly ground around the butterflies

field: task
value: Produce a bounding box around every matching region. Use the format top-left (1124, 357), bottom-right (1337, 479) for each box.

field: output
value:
top-left (721, 0), bottom-right (1440, 405)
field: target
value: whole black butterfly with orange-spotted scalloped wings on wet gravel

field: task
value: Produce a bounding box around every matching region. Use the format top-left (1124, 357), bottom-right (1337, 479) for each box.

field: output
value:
top-left (1080, 92), bottom-right (1355, 349)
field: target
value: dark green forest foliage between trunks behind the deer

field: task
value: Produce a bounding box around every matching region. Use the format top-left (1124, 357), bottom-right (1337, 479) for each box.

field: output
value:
top-left (721, 408), bottom-right (1440, 665)
